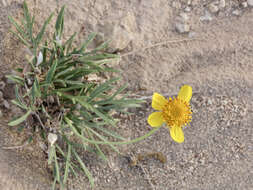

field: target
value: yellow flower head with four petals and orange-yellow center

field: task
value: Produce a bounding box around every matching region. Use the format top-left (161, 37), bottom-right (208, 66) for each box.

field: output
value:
top-left (148, 85), bottom-right (192, 143)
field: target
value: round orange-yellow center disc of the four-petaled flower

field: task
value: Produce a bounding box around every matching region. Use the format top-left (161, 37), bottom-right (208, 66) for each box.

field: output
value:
top-left (162, 98), bottom-right (192, 127)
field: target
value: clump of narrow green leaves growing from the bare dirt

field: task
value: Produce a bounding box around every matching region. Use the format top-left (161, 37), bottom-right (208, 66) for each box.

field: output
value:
top-left (7, 2), bottom-right (146, 188)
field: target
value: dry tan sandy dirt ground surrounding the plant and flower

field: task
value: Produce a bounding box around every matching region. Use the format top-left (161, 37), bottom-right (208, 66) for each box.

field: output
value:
top-left (0, 0), bottom-right (253, 190)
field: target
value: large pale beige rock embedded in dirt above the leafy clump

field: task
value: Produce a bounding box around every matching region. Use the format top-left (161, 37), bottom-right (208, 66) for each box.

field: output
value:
top-left (95, 12), bottom-right (137, 52)
